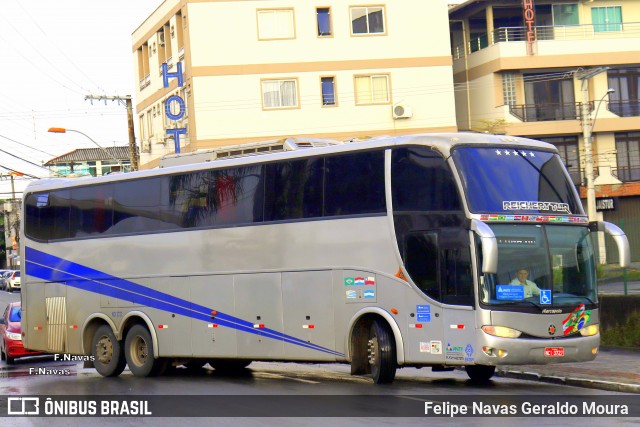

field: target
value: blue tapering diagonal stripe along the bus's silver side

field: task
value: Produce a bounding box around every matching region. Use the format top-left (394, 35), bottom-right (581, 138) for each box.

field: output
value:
top-left (25, 247), bottom-right (344, 357)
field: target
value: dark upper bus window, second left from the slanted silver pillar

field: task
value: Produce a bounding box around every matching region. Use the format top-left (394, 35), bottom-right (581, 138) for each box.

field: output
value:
top-left (264, 158), bottom-right (324, 221)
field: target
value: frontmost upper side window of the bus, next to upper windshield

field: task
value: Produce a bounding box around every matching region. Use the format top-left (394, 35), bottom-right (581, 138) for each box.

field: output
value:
top-left (391, 147), bottom-right (462, 212)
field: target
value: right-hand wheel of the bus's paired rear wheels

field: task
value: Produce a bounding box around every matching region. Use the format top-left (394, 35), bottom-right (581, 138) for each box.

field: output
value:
top-left (124, 325), bottom-right (159, 377)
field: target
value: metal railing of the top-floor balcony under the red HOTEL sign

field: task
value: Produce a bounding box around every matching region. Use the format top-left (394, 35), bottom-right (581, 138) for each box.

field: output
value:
top-left (452, 22), bottom-right (640, 59)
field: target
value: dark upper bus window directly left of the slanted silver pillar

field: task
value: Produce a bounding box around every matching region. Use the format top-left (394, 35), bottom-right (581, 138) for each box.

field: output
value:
top-left (324, 151), bottom-right (386, 216)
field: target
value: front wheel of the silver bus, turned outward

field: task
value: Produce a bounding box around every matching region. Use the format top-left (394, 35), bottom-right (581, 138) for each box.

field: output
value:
top-left (367, 319), bottom-right (396, 384)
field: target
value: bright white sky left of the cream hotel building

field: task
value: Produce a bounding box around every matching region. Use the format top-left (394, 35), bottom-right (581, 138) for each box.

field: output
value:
top-left (0, 0), bottom-right (163, 199)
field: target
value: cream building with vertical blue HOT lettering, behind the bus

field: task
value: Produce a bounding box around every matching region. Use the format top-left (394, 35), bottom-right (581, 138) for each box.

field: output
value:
top-left (133, 0), bottom-right (457, 169)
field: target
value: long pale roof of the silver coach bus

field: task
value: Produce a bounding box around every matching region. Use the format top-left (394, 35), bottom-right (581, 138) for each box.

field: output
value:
top-left (24, 132), bottom-right (557, 195)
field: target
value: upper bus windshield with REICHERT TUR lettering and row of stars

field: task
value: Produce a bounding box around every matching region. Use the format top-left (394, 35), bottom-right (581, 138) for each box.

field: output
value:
top-left (453, 147), bottom-right (583, 215)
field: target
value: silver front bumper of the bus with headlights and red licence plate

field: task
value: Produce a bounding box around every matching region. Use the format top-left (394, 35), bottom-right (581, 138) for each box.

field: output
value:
top-left (474, 334), bottom-right (600, 366)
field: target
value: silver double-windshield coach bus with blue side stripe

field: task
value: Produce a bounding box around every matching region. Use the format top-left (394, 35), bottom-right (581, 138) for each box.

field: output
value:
top-left (21, 133), bottom-right (629, 383)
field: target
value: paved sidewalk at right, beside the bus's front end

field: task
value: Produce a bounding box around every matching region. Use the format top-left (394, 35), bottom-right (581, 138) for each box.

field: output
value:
top-left (496, 348), bottom-right (640, 393)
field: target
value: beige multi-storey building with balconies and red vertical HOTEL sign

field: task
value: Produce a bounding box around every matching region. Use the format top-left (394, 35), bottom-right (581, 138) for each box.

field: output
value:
top-left (449, 0), bottom-right (640, 261)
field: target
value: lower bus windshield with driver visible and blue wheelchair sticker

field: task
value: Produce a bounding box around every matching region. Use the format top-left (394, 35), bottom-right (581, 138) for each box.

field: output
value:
top-left (479, 224), bottom-right (597, 309)
